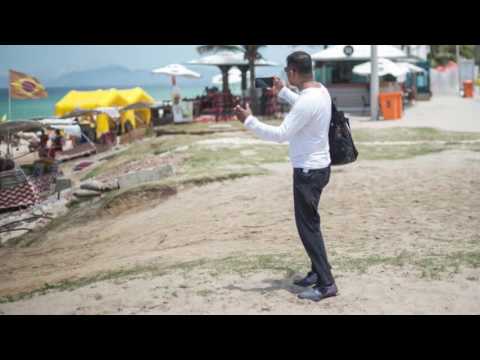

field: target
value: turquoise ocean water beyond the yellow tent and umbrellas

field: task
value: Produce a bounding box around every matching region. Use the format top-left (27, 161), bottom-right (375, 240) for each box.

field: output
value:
top-left (0, 86), bottom-right (239, 120)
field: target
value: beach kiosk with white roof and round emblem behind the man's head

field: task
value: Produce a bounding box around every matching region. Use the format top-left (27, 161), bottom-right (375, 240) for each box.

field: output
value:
top-left (312, 45), bottom-right (407, 115)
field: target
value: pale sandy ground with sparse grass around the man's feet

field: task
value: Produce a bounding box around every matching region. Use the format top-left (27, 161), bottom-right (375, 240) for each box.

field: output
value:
top-left (0, 97), bottom-right (480, 314)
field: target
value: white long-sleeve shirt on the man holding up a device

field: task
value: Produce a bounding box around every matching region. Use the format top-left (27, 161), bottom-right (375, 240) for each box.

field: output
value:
top-left (245, 86), bottom-right (332, 169)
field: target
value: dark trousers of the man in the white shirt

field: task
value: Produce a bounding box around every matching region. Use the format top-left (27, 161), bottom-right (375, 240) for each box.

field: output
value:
top-left (293, 167), bottom-right (335, 287)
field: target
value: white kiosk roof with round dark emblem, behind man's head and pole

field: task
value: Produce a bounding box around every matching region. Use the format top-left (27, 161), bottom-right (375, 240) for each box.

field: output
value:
top-left (312, 45), bottom-right (407, 61)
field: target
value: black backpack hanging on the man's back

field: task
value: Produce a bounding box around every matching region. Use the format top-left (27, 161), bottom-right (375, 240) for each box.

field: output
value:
top-left (328, 103), bottom-right (358, 166)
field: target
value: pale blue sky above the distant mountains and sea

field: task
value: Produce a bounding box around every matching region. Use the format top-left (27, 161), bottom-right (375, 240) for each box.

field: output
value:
top-left (0, 45), bottom-right (322, 79)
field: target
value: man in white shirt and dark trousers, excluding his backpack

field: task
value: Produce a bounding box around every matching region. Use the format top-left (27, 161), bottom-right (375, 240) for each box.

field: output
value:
top-left (235, 51), bottom-right (337, 301)
